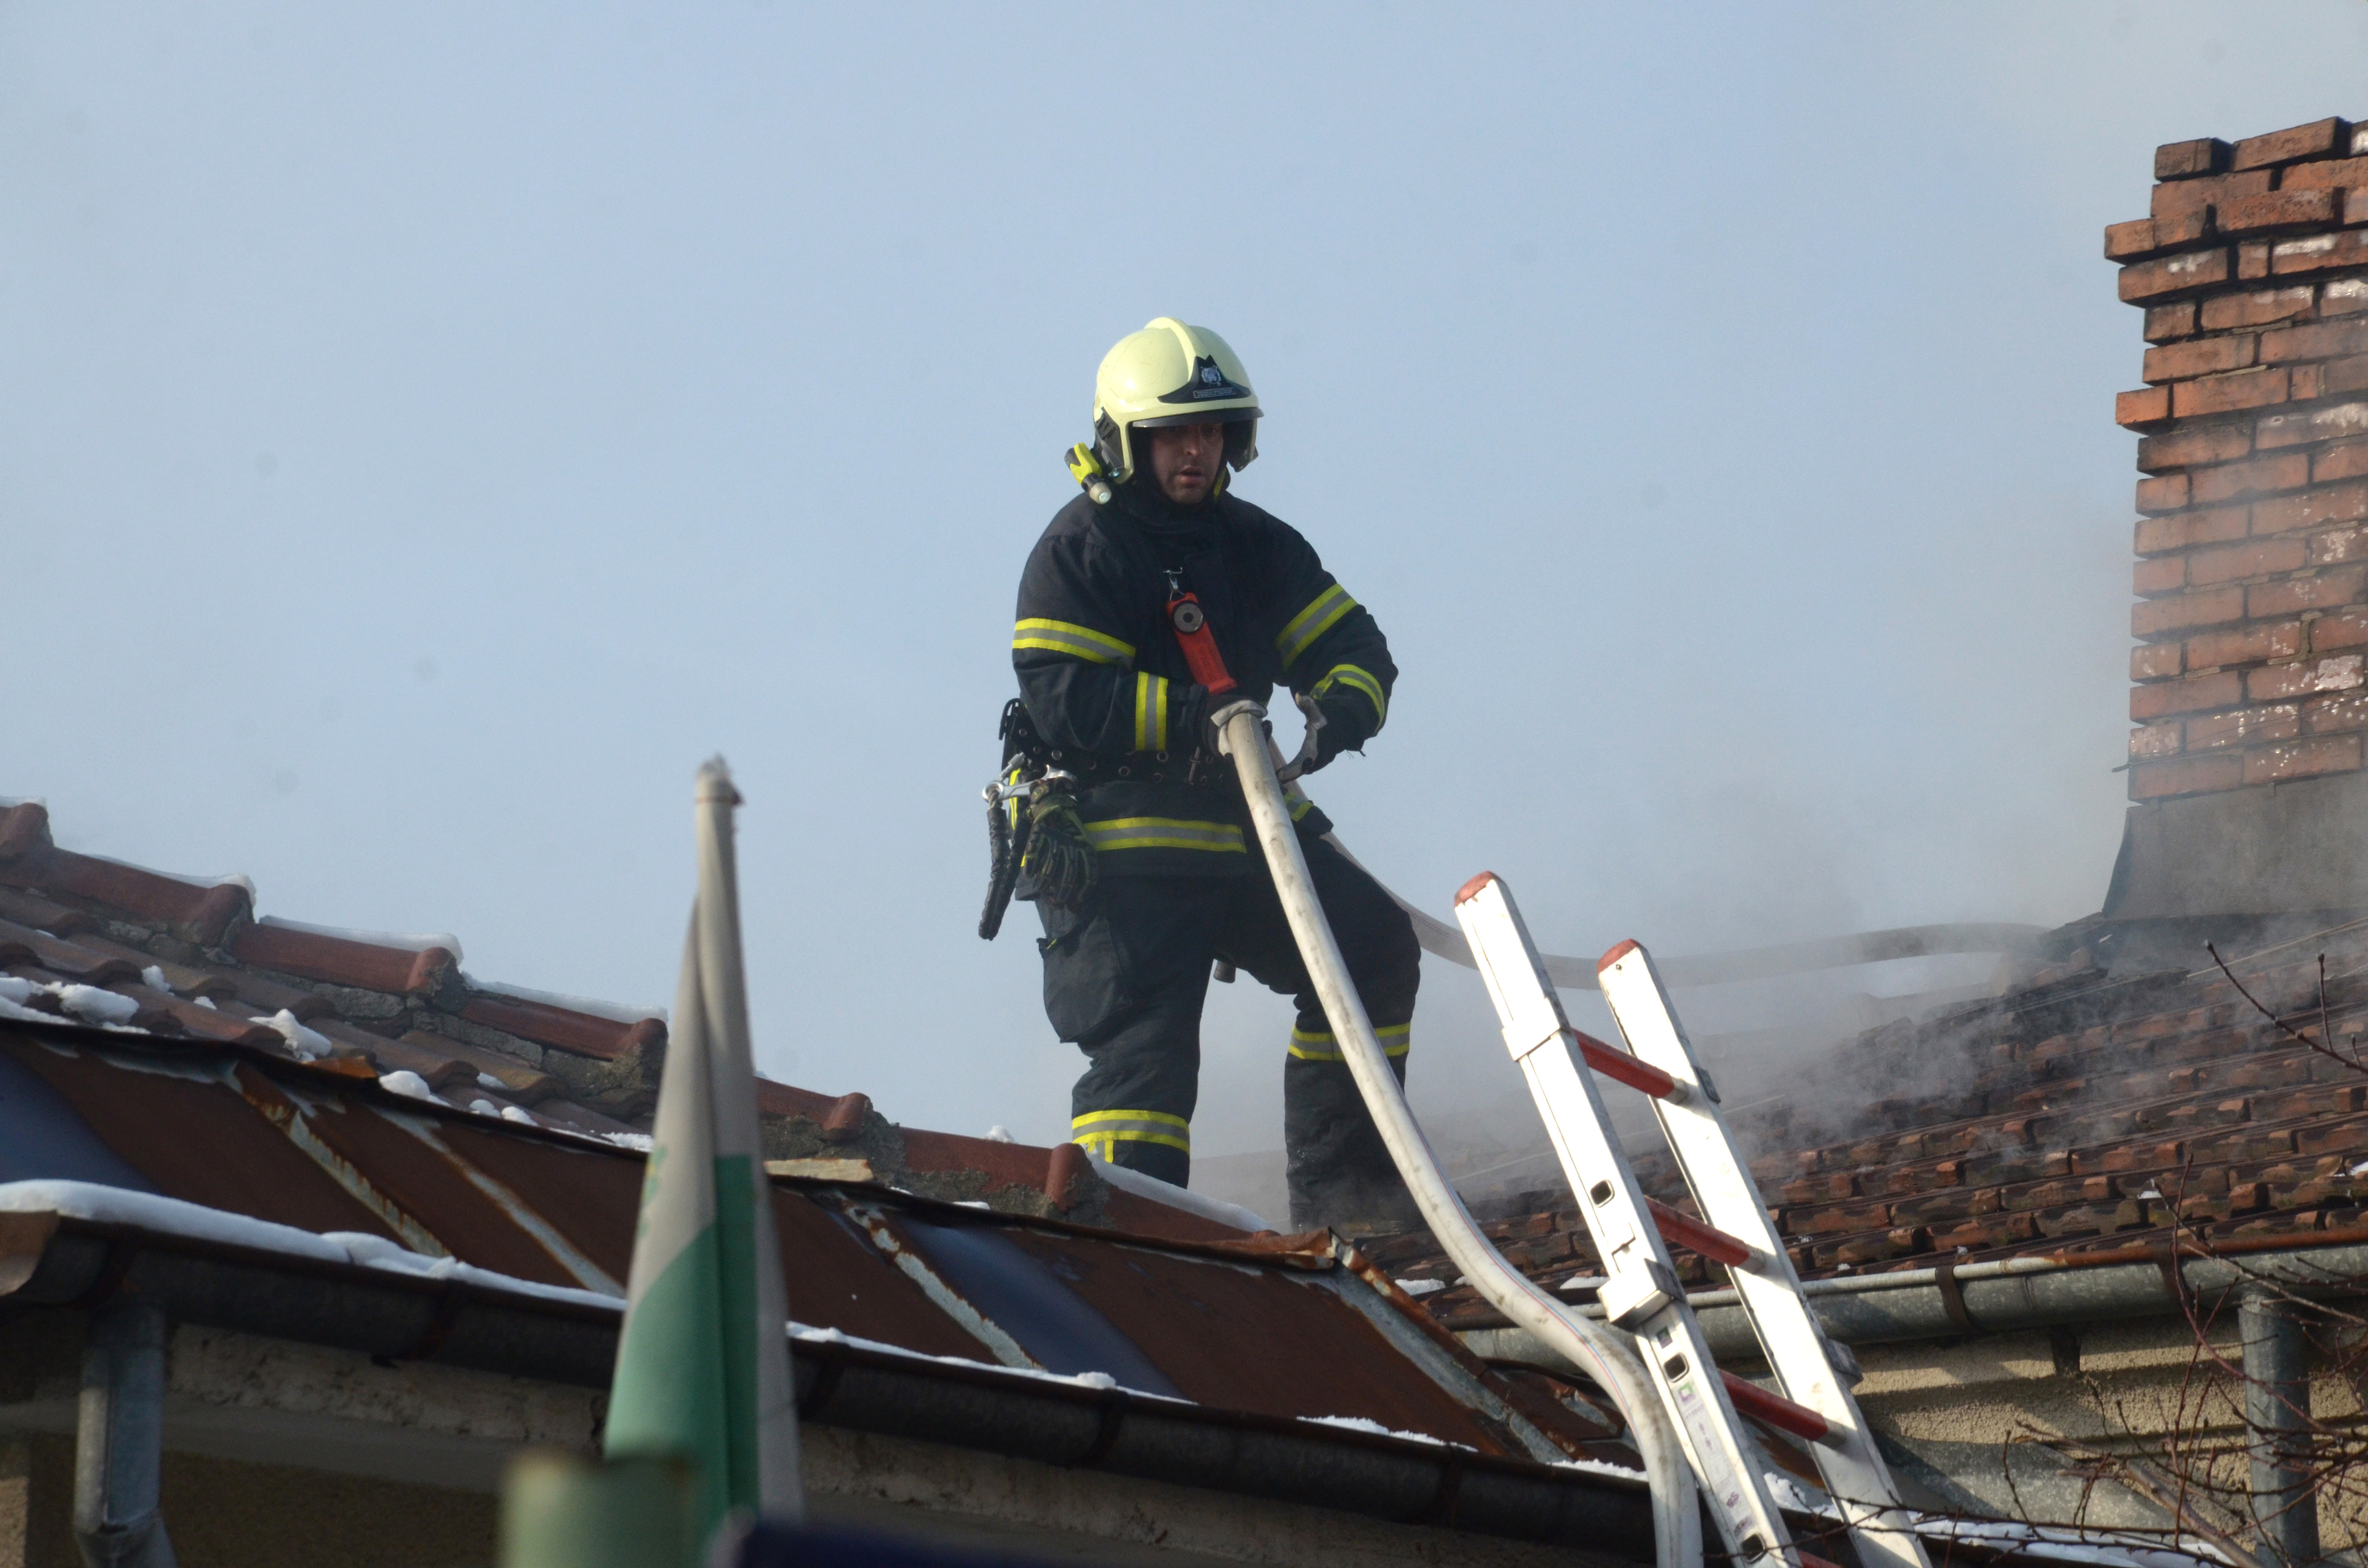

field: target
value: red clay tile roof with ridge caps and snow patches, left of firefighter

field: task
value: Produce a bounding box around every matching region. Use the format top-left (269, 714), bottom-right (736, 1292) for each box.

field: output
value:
top-left (0, 801), bottom-right (1238, 1274)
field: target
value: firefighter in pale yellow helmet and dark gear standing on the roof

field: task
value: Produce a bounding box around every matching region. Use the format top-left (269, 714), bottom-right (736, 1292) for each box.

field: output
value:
top-left (1011, 318), bottom-right (1421, 1229)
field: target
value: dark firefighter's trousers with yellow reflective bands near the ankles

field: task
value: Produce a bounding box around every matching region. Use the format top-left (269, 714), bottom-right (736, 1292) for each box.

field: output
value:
top-left (1037, 838), bottom-right (1421, 1229)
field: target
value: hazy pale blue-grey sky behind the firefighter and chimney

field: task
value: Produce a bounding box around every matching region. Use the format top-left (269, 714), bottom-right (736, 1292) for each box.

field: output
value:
top-left (0, 0), bottom-right (2368, 1151)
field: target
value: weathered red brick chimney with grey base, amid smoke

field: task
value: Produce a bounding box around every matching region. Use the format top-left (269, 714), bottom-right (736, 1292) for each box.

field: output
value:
top-left (2105, 119), bottom-right (2368, 919)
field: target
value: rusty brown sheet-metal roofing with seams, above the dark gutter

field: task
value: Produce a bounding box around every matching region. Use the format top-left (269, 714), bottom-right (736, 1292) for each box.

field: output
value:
top-left (0, 1023), bottom-right (1620, 1464)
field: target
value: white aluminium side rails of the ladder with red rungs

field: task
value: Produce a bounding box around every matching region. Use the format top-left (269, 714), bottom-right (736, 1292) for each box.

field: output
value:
top-left (1456, 871), bottom-right (1930, 1568)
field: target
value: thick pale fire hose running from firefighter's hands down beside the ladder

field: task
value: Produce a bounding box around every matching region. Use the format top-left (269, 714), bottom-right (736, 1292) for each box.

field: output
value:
top-left (1210, 701), bottom-right (1702, 1568)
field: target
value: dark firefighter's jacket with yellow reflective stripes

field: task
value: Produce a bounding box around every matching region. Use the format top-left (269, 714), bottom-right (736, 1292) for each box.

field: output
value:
top-left (1011, 486), bottom-right (1397, 876)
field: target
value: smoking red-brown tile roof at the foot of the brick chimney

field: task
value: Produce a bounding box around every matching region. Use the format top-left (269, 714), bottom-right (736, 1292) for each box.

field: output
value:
top-left (1369, 924), bottom-right (2368, 1326)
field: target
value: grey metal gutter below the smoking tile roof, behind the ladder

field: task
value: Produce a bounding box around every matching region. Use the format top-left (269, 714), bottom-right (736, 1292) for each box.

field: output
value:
top-left (1459, 1229), bottom-right (2368, 1364)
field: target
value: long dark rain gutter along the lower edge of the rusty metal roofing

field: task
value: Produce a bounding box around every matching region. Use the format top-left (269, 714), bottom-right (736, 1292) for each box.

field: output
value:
top-left (0, 1213), bottom-right (1653, 1563)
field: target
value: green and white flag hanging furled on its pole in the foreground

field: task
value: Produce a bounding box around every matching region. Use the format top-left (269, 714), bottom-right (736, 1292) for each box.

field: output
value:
top-left (608, 758), bottom-right (801, 1537)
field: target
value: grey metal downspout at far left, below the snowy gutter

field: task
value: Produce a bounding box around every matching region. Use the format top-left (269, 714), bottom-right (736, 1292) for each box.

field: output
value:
top-left (74, 1296), bottom-right (175, 1568)
